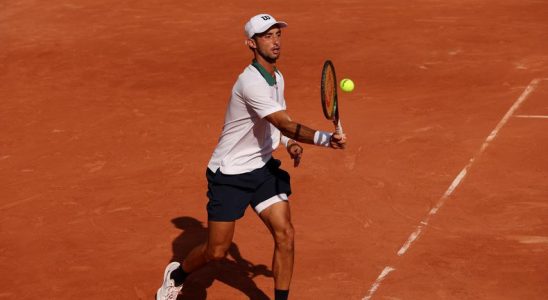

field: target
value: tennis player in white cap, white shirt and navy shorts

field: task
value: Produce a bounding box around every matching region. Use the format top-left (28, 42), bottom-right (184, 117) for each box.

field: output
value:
top-left (156, 14), bottom-right (346, 300)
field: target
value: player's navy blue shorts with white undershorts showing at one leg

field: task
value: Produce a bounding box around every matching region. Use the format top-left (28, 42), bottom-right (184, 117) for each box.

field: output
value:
top-left (206, 158), bottom-right (291, 222)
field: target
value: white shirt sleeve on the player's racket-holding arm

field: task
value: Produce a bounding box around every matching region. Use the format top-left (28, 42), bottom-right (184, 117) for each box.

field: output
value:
top-left (243, 84), bottom-right (283, 119)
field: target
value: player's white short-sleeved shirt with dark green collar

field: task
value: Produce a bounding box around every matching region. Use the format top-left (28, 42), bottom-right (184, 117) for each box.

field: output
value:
top-left (207, 64), bottom-right (286, 174)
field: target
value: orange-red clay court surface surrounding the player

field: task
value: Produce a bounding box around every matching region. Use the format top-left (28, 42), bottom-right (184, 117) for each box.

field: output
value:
top-left (0, 0), bottom-right (548, 300)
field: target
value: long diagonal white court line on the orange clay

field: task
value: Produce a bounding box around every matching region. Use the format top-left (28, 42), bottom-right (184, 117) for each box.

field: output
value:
top-left (362, 78), bottom-right (548, 300)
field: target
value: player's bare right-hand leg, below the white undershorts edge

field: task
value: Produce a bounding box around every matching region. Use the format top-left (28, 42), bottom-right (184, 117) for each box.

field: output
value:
top-left (259, 201), bottom-right (295, 291)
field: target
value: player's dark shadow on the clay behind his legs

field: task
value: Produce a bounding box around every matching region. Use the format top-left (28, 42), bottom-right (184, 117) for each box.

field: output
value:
top-left (171, 217), bottom-right (272, 300)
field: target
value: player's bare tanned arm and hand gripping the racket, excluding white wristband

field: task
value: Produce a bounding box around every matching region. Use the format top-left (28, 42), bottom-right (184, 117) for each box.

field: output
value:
top-left (265, 110), bottom-right (346, 149)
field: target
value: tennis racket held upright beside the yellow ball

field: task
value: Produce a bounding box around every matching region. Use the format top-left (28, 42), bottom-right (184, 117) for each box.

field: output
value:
top-left (321, 60), bottom-right (343, 134)
